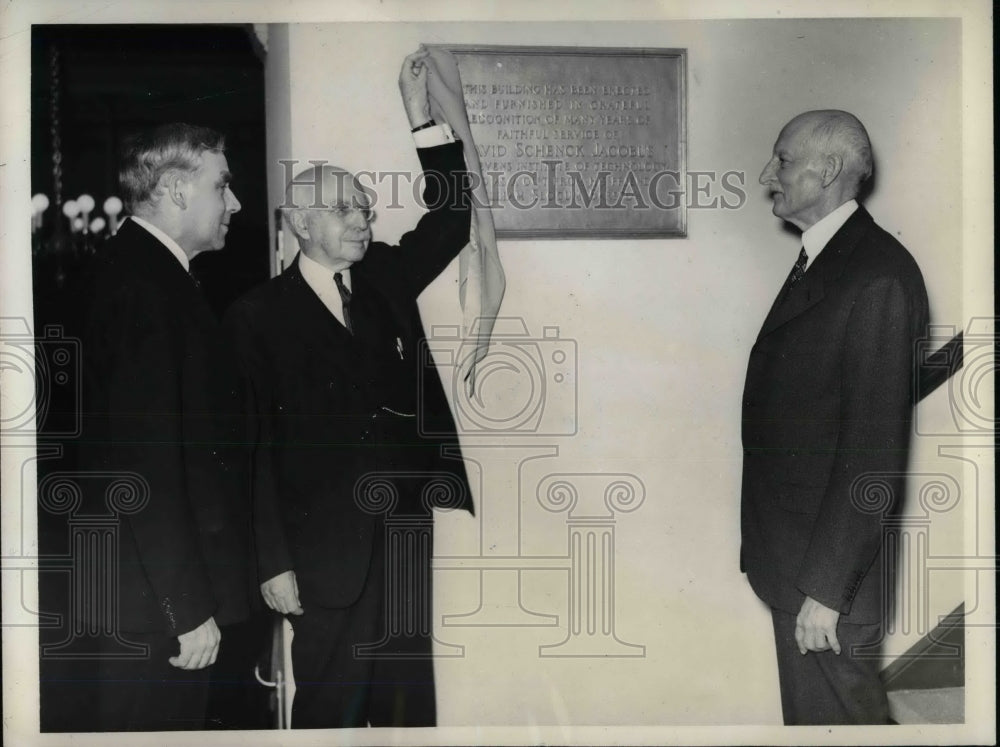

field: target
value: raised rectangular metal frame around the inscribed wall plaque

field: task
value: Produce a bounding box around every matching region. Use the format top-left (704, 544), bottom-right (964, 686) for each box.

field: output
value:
top-left (440, 44), bottom-right (688, 239)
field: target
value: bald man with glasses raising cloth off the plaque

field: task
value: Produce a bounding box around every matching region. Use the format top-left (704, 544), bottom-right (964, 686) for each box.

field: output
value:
top-left (227, 51), bottom-right (472, 728)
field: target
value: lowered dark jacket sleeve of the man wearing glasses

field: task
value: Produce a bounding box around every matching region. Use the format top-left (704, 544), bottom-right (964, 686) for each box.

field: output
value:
top-left (223, 302), bottom-right (294, 582)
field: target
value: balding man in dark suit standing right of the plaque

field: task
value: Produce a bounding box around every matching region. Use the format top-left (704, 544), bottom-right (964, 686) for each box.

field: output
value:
top-left (741, 111), bottom-right (928, 724)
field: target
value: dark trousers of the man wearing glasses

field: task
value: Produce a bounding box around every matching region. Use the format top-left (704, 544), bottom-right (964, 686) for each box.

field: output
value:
top-left (288, 519), bottom-right (437, 729)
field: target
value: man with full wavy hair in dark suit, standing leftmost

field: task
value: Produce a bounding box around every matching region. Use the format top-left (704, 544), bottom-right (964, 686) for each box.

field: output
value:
top-left (73, 124), bottom-right (252, 730)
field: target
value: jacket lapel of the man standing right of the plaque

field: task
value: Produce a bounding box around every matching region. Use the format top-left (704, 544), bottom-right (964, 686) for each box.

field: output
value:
top-left (757, 206), bottom-right (873, 340)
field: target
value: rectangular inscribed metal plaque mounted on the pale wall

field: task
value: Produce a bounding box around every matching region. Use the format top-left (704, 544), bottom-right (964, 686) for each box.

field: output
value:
top-left (442, 45), bottom-right (687, 238)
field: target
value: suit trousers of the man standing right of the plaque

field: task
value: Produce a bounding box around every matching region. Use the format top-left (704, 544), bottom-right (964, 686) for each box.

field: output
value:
top-left (771, 608), bottom-right (889, 726)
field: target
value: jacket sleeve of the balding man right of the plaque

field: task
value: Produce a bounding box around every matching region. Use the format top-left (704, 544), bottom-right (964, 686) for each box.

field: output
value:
top-left (796, 278), bottom-right (920, 614)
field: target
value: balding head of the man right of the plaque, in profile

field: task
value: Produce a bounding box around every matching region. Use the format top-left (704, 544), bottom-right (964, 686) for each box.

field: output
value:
top-left (760, 109), bottom-right (872, 231)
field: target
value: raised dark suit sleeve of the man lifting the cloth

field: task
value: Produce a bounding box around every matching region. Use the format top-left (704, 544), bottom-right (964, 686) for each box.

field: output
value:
top-left (363, 142), bottom-right (472, 300)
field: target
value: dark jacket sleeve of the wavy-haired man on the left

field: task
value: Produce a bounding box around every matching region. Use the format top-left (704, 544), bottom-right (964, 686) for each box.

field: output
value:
top-left (102, 294), bottom-right (215, 636)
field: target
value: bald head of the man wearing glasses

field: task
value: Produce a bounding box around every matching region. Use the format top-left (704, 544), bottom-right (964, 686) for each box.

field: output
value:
top-left (283, 164), bottom-right (373, 271)
